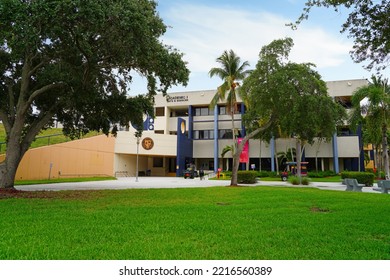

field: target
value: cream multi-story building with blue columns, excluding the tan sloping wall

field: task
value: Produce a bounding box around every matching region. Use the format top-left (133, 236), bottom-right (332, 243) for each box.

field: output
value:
top-left (115, 79), bottom-right (367, 176)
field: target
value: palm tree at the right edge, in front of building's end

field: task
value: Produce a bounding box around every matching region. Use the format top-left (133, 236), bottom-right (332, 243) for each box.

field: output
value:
top-left (350, 76), bottom-right (390, 179)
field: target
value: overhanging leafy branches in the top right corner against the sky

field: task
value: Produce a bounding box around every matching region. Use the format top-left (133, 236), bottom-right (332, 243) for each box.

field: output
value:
top-left (294, 0), bottom-right (390, 70)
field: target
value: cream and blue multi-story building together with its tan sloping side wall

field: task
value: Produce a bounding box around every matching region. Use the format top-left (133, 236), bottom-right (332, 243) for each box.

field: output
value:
top-left (7, 79), bottom-right (368, 179)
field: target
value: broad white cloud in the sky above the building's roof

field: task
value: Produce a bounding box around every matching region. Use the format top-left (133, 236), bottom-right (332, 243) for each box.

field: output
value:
top-left (164, 2), bottom-right (351, 72)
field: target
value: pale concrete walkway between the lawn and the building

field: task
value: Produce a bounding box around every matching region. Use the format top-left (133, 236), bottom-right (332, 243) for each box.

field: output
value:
top-left (16, 177), bottom-right (380, 194)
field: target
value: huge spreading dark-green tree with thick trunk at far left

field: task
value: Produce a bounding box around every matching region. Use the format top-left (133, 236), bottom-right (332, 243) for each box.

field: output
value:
top-left (0, 0), bottom-right (189, 188)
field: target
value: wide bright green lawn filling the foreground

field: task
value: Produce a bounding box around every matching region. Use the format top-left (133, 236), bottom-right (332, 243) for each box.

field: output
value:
top-left (0, 187), bottom-right (390, 260)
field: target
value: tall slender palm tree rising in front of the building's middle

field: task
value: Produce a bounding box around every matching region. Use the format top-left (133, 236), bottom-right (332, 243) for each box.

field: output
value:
top-left (209, 50), bottom-right (251, 174)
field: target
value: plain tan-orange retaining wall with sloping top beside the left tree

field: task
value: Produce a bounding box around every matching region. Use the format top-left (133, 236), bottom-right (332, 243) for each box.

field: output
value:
top-left (7, 135), bottom-right (115, 180)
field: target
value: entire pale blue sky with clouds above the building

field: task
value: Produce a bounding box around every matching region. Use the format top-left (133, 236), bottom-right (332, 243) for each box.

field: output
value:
top-left (131, 0), bottom-right (388, 94)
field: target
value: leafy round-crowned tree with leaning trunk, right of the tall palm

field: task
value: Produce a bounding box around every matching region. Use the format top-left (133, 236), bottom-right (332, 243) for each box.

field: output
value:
top-left (231, 38), bottom-right (345, 185)
